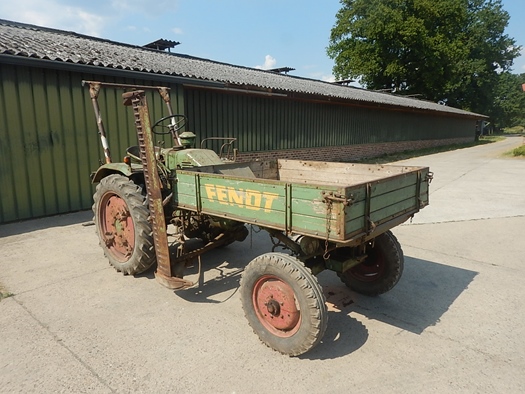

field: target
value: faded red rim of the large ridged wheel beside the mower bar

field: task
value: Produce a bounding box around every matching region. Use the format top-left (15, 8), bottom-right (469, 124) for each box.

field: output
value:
top-left (99, 193), bottom-right (135, 263)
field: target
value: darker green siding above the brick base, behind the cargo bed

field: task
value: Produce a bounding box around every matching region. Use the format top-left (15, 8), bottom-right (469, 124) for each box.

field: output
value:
top-left (185, 89), bottom-right (475, 152)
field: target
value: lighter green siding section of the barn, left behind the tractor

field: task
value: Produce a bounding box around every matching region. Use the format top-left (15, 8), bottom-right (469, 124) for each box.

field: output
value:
top-left (0, 64), bottom-right (184, 223)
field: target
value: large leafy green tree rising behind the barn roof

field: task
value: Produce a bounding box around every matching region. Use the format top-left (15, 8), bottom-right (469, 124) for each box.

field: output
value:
top-left (327, 0), bottom-right (521, 124)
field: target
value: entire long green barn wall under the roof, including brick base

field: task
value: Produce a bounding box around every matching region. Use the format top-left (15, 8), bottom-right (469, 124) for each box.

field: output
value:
top-left (0, 63), bottom-right (474, 223)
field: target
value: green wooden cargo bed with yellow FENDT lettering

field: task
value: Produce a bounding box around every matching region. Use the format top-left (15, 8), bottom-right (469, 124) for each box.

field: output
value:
top-left (173, 160), bottom-right (431, 244)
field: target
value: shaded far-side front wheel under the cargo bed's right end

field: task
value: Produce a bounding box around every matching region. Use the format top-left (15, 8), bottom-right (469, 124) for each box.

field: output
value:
top-left (338, 231), bottom-right (404, 296)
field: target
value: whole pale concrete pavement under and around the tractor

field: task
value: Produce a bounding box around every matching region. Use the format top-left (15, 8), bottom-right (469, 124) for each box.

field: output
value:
top-left (0, 138), bottom-right (525, 393)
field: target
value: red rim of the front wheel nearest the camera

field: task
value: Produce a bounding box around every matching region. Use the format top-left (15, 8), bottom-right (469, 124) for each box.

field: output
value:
top-left (252, 275), bottom-right (301, 338)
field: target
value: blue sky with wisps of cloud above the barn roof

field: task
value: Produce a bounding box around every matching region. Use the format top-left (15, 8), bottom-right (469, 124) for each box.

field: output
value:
top-left (0, 0), bottom-right (525, 85)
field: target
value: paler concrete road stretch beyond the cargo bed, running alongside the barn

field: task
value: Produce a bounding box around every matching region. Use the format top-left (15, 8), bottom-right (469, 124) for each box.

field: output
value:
top-left (400, 136), bottom-right (525, 223)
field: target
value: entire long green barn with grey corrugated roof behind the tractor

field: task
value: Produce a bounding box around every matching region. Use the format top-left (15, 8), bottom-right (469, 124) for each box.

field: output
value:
top-left (0, 20), bottom-right (485, 223)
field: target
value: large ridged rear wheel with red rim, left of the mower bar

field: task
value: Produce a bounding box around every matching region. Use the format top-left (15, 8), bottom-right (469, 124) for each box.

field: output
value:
top-left (93, 174), bottom-right (156, 275)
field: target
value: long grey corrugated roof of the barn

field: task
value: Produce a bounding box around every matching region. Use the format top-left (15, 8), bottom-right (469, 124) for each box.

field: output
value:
top-left (0, 19), bottom-right (485, 118)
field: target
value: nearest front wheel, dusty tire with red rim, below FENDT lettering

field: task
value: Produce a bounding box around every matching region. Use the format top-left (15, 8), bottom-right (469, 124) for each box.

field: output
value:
top-left (240, 253), bottom-right (328, 356)
